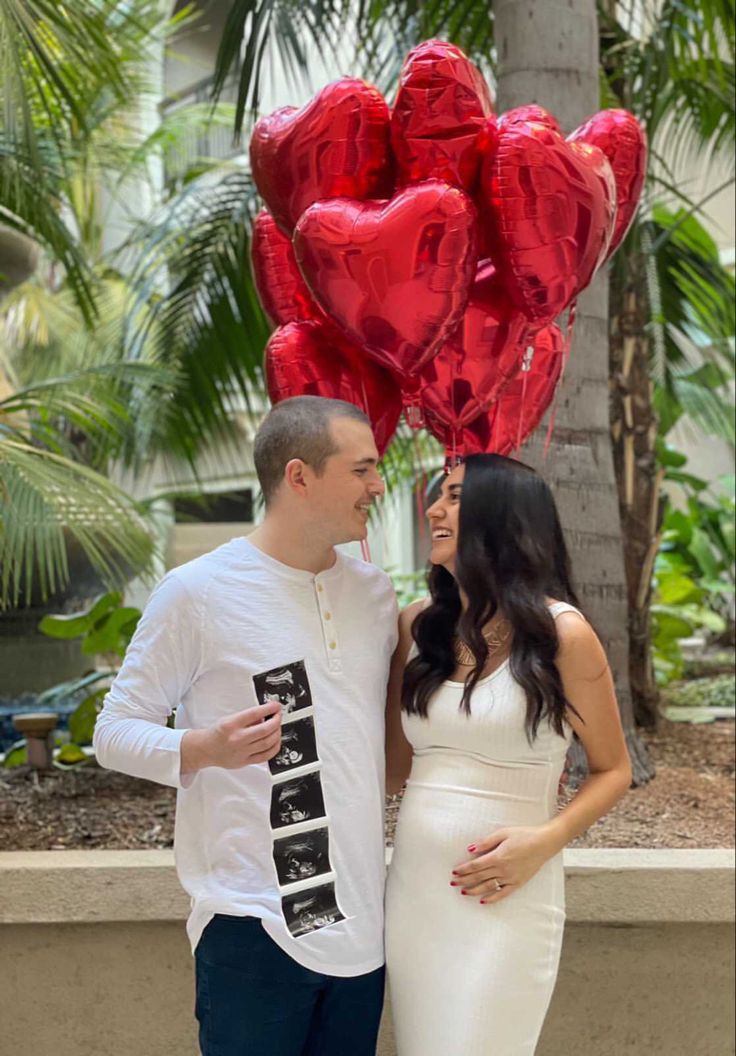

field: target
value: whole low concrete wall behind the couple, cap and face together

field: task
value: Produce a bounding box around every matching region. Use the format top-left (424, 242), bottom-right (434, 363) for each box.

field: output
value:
top-left (0, 849), bottom-right (735, 1056)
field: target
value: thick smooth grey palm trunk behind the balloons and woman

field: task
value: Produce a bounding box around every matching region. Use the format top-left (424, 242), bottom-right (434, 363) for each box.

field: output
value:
top-left (493, 0), bottom-right (654, 784)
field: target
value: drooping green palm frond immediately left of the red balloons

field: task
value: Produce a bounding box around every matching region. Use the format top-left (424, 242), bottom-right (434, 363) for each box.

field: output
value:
top-left (125, 166), bottom-right (269, 470)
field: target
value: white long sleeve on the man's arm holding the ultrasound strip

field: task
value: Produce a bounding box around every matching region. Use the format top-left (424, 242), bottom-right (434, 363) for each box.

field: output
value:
top-left (93, 571), bottom-right (202, 788)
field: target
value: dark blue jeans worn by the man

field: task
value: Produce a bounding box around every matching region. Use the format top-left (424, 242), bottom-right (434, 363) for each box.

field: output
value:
top-left (195, 916), bottom-right (384, 1056)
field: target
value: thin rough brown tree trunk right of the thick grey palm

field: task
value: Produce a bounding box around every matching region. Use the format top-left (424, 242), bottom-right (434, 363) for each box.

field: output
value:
top-left (610, 276), bottom-right (664, 728)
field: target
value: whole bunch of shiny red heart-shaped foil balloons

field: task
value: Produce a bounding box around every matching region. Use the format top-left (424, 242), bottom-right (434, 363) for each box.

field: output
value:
top-left (250, 40), bottom-right (646, 457)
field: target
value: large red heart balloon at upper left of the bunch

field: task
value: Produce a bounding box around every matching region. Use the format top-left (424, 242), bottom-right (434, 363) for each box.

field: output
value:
top-left (250, 77), bottom-right (392, 235)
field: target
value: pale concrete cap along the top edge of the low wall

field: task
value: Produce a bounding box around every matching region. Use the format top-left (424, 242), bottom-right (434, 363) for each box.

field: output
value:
top-left (0, 848), bottom-right (736, 925)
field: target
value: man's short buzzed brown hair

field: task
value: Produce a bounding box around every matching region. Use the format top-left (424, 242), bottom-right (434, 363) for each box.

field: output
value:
top-left (253, 396), bottom-right (371, 506)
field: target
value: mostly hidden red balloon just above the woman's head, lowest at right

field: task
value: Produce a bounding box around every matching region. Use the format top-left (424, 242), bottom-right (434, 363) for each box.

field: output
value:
top-left (427, 324), bottom-right (565, 458)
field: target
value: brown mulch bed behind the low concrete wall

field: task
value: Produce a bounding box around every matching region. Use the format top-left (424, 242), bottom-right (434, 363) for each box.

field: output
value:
top-left (0, 719), bottom-right (735, 851)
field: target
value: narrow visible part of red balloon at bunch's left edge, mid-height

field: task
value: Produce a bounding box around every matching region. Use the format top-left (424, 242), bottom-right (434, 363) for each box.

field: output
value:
top-left (250, 209), bottom-right (324, 326)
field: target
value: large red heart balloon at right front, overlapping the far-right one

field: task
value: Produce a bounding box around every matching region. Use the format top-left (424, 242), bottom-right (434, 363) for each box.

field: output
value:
top-left (480, 108), bottom-right (616, 326)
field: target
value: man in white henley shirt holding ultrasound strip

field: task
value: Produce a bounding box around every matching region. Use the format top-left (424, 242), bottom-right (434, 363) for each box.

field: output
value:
top-left (94, 396), bottom-right (396, 1056)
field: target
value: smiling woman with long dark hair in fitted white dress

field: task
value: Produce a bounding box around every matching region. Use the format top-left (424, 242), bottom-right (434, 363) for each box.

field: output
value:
top-left (386, 455), bottom-right (631, 1056)
